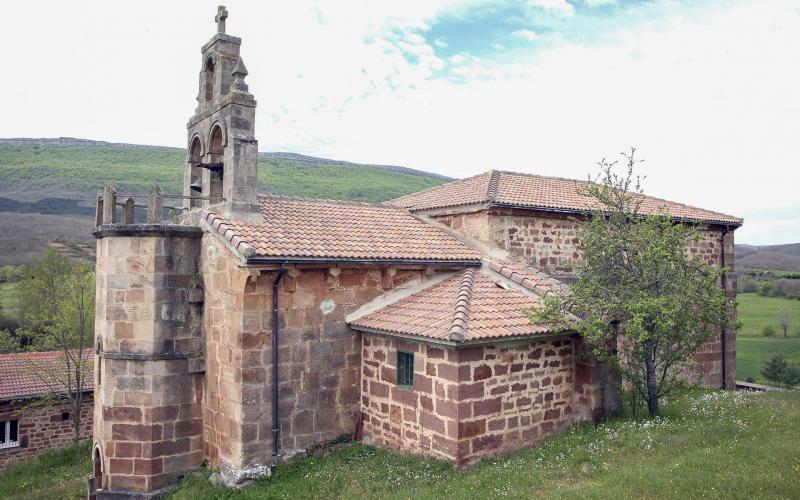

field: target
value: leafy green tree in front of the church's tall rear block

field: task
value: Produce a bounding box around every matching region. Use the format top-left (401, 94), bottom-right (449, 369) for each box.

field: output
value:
top-left (529, 149), bottom-right (730, 415)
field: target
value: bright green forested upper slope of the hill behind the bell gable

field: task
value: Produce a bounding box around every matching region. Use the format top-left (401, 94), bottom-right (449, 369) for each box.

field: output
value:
top-left (0, 138), bottom-right (450, 204)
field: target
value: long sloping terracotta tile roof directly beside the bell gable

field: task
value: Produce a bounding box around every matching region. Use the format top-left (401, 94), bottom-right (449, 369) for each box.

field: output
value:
top-left (205, 195), bottom-right (480, 264)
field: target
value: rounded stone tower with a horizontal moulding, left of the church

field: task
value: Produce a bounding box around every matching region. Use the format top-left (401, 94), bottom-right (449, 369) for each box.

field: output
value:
top-left (94, 226), bottom-right (203, 493)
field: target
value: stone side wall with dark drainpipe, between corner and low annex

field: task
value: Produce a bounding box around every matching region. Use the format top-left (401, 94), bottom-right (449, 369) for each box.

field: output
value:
top-left (231, 267), bottom-right (432, 472)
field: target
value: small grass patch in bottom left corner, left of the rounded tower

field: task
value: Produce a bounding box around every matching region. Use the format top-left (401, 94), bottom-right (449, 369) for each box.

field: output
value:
top-left (0, 441), bottom-right (92, 500)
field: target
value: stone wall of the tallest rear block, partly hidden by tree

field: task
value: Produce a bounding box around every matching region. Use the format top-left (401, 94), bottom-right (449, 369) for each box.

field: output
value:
top-left (436, 209), bottom-right (736, 388)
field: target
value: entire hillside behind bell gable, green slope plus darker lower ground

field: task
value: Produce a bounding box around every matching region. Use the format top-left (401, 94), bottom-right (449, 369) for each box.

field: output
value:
top-left (0, 137), bottom-right (450, 265)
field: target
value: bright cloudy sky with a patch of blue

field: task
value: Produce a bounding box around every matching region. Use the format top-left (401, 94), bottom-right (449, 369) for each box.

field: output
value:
top-left (0, 0), bottom-right (800, 244)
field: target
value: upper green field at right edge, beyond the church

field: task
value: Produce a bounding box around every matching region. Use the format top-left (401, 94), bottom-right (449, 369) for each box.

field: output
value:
top-left (737, 293), bottom-right (800, 337)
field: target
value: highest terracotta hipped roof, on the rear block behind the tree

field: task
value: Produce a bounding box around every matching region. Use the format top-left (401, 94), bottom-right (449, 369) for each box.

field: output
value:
top-left (386, 170), bottom-right (742, 225)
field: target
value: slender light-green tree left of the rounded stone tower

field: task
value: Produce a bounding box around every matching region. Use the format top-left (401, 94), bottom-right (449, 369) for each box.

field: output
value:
top-left (0, 249), bottom-right (95, 441)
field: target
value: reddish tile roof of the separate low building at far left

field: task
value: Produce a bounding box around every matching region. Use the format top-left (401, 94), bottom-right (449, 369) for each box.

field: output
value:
top-left (0, 349), bottom-right (94, 401)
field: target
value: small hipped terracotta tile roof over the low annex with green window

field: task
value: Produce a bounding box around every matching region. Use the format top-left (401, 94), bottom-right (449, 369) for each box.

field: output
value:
top-left (350, 269), bottom-right (552, 342)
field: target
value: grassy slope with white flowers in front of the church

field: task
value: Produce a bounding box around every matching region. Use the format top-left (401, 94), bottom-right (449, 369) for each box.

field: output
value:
top-left (164, 391), bottom-right (800, 500)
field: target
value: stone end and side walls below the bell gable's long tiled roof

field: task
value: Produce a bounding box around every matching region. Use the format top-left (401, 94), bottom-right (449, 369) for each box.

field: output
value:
top-left (201, 236), bottom-right (440, 482)
